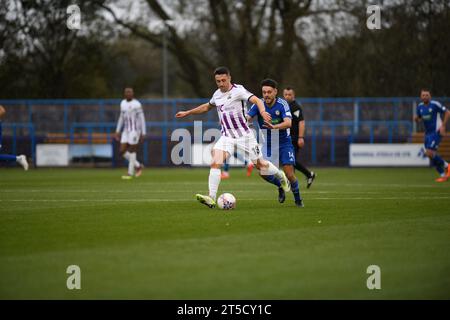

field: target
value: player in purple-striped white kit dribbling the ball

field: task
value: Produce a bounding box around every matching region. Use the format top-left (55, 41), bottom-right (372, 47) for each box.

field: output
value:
top-left (176, 67), bottom-right (290, 208)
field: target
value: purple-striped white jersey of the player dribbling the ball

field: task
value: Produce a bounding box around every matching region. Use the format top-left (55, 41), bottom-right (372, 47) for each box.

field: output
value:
top-left (209, 84), bottom-right (253, 139)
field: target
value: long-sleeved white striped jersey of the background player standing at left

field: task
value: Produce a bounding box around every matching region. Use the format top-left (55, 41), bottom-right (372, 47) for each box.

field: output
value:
top-left (116, 99), bottom-right (147, 135)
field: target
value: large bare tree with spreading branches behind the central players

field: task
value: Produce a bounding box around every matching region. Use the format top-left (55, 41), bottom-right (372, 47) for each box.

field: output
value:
top-left (101, 0), bottom-right (358, 96)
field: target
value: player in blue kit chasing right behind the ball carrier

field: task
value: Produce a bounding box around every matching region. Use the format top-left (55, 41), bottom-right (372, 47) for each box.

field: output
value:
top-left (247, 79), bottom-right (304, 207)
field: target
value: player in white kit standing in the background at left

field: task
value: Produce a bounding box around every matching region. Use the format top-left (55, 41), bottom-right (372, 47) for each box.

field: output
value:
top-left (116, 88), bottom-right (147, 179)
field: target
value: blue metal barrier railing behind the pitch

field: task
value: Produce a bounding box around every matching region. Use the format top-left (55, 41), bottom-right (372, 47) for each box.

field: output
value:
top-left (0, 97), bottom-right (450, 165)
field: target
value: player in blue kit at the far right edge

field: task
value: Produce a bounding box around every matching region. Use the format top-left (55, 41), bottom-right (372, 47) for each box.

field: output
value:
top-left (414, 89), bottom-right (450, 182)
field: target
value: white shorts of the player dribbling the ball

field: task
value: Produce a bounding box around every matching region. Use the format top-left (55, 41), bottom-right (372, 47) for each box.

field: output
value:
top-left (213, 132), bottom-right (262, 162)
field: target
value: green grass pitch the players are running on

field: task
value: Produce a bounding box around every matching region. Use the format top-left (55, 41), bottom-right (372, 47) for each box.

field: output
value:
top-left (0, 168), bottom-right (450, 299)
